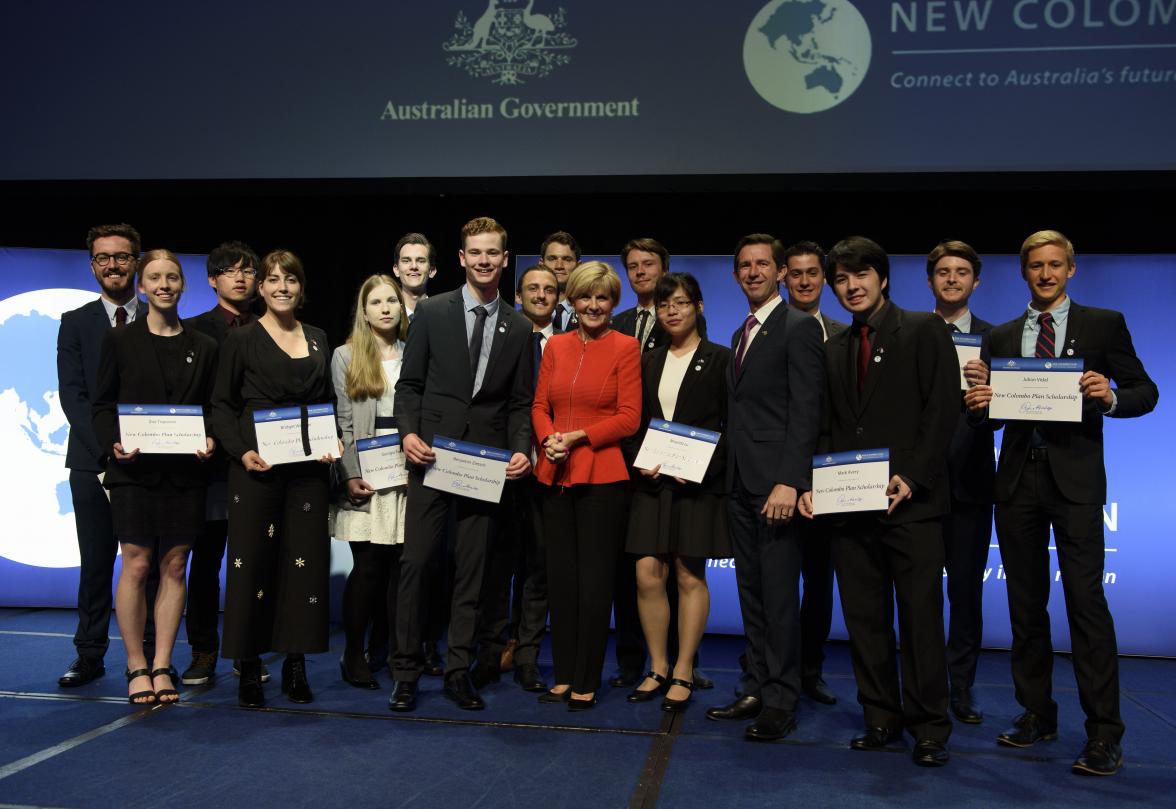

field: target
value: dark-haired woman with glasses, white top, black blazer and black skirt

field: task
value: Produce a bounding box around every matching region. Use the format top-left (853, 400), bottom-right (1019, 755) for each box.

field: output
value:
top-left (626, 273), bottom-right (731, 710)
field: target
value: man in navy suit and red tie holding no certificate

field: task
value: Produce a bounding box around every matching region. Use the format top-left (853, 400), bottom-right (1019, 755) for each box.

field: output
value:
top-left (707, 234), bottom-right (824, 741)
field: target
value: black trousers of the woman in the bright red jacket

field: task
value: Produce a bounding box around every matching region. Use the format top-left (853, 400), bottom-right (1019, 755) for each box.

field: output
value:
top-left (542, 481), bottom-right (630, 694)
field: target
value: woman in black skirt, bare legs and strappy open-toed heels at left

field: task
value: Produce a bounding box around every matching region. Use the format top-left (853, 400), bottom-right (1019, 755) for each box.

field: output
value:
top-left (93, 250), bottom-right (216, 704)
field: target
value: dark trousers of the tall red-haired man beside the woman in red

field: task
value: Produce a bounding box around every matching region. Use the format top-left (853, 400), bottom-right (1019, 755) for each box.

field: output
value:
top-left (393, 468), bottom-right (491, 682)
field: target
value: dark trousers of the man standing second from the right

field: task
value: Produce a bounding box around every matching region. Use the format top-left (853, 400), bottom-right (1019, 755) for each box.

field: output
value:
top-left (943, 497), bottom-right (993, 688)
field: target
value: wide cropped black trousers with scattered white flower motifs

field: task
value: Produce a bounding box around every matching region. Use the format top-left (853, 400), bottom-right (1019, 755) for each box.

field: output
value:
top-left (221, 461), bottom-right (330, 658)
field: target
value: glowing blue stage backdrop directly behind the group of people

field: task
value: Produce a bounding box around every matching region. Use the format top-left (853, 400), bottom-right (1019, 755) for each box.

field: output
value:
top-left (0, 248), bottom-right (1176, 655)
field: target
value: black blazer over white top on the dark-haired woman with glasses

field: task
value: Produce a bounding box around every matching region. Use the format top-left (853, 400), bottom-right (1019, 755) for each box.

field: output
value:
top-left (622, 340), bottom-right (730, 495)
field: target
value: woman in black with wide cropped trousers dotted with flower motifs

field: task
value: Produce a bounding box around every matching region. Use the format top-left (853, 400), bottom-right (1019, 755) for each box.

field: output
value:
top-left (213, 250), bottom-right (338, 708)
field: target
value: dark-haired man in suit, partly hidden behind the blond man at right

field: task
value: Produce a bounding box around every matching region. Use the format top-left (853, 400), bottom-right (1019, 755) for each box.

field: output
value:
top-left (927, 240), bottom-right (996, 724)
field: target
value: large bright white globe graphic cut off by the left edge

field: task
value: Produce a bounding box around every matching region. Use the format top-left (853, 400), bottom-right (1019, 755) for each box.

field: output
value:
top-left (0, 289), bottom-right (96, 568)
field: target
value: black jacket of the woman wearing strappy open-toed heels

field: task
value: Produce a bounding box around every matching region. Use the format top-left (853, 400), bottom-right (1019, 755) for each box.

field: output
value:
top-left (93, 316), bottom-right (216, 488)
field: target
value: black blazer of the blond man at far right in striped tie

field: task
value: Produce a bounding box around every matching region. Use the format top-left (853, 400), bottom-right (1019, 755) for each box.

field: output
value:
top-left (991, 300), bottom-right (1160, 504)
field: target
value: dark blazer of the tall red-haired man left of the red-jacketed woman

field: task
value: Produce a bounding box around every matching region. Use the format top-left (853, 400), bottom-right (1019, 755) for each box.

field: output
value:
top-left (396, 287), bottom-right (534, 455)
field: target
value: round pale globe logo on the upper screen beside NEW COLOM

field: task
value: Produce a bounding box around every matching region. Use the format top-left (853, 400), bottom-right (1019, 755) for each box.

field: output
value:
top-left (743, 0), bottom-right (871, 113)
